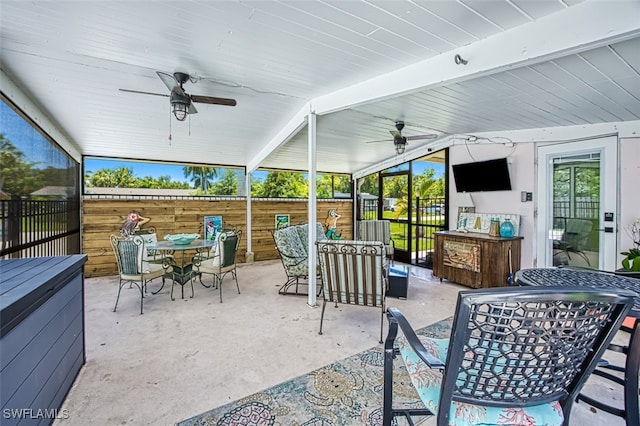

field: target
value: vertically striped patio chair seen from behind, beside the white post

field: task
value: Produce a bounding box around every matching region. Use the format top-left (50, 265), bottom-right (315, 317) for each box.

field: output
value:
top-left (316, 240), bottom-right (388, 343)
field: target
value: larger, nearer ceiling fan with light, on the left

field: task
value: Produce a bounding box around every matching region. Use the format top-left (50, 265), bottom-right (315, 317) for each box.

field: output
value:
top-left (120, 71), bottom-right (236, 121)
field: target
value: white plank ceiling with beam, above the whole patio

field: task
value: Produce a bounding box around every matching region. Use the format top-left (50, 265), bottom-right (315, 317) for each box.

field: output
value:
top-left (0, 0), bottom-right (640, 173)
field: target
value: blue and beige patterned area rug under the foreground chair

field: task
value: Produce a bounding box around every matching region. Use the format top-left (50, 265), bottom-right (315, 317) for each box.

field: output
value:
top-left (177, 318), bottom-right (451, 426)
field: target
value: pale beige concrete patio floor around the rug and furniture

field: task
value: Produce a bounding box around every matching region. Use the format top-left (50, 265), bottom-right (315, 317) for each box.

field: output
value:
top-left (54, 261), bottom-right (624, 426)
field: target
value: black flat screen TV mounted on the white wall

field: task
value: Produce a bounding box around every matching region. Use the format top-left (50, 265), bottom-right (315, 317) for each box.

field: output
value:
top-left (451, 158), bottom-right (511, 192)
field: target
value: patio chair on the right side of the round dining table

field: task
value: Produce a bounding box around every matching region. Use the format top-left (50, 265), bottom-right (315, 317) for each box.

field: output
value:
top-left (193, 230), bottom-right (242, 303)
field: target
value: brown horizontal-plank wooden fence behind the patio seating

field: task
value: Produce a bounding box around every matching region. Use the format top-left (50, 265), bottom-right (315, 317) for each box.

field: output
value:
top-left (82, 197), bottom-right (353, 277)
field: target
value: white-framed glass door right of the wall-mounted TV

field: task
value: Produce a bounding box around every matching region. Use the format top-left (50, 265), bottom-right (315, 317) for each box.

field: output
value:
top-left (536, 136), bottom-right (618, 270)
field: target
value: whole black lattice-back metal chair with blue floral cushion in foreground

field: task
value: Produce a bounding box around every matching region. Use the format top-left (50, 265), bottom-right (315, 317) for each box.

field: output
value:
top-left (383, 286), bottom-right (634, 426)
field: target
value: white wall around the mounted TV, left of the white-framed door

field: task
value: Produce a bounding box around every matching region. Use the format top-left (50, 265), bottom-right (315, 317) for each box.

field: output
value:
top-left (449, 143), bottom-right (535, 268)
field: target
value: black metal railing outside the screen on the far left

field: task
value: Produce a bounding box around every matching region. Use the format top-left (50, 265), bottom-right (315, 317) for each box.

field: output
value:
top-left (0, 197), bottom-right (80, 258)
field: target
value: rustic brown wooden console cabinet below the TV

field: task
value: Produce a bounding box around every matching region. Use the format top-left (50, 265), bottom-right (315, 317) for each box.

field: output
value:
top-left (433, 231), bottom-right (522, 288)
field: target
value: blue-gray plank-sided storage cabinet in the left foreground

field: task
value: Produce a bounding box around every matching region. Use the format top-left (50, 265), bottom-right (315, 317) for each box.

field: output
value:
top-left (0, 255), bottom-right (87, 425)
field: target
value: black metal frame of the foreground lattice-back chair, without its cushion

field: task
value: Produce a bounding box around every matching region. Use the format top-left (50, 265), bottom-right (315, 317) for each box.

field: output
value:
top-left (385, 287), bottom-right (635, 425)
